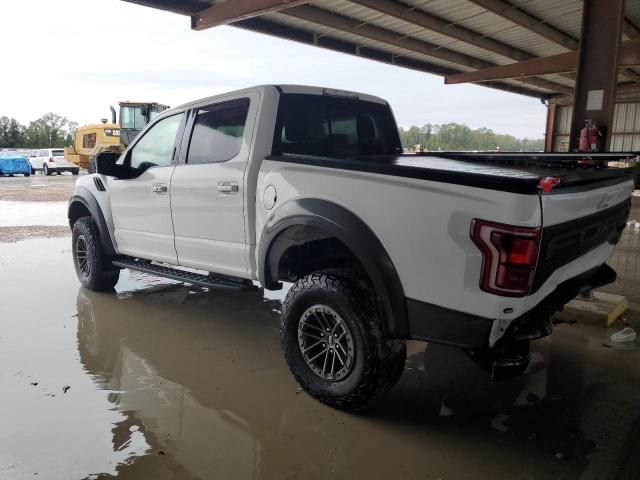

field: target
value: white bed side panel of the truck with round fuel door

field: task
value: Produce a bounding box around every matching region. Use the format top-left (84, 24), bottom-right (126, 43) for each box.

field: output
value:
top-left (256, 160), bottom-right (541, 319)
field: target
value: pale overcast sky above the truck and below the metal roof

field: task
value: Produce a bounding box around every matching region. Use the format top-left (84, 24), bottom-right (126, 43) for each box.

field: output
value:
top-left (0, 0), bottom-right (546, 138)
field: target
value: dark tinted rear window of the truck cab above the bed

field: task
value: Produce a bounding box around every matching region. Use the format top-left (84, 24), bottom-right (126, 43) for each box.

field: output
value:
top-left (272, 94), bottom-right (402, 157)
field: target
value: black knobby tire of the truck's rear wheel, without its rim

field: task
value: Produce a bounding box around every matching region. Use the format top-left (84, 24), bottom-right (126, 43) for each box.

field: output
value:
top-left (280, 270), bottom-right (407, 411)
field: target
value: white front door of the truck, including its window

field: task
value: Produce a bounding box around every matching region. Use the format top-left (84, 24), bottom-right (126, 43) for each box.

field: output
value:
top-left (109, 113), bottom-right (185, 264)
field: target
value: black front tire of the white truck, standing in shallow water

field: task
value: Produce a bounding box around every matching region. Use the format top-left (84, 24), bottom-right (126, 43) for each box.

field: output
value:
top-left (71, 217), bottom-right (120, 292)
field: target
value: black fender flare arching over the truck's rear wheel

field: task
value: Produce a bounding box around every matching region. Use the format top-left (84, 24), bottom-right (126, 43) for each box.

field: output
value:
top-left (258, 198), bottom-right (409, 338)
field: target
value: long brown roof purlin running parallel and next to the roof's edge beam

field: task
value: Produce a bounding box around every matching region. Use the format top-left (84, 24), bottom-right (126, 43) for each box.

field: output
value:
top-left (282, 5), bottom-right (572, 94)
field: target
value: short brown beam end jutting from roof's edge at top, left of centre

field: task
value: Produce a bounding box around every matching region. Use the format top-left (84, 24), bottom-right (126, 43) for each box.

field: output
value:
top-left (191, 0), bottom-right (311, 30)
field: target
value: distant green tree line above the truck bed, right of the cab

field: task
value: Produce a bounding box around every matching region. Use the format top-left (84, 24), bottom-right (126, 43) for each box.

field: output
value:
top-left (400, 123), bottom-right (544, 152)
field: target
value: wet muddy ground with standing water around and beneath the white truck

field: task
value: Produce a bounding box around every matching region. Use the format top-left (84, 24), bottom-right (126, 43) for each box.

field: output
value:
top-left (0, 177), bottom-right (640, 480)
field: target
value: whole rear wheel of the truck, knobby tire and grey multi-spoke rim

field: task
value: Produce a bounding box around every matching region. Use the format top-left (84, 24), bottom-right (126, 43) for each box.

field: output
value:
top-left (281, 271), bottom-right (406, 410)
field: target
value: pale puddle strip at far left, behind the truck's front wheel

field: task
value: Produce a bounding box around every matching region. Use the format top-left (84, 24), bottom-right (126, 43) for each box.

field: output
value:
top-left (0, 200), bottom-right (69, 227)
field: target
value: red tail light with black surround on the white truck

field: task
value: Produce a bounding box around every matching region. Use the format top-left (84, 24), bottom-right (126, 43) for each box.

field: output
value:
top-left (471, 218), bottom-right (540, 297)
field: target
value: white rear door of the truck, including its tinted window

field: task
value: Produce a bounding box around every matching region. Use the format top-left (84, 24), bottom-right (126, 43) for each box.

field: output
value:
top-left (171, 93), bottom-right (258, 277)
